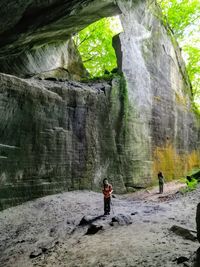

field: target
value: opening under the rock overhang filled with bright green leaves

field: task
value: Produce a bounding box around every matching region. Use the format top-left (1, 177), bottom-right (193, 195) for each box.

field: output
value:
top-left (73, 16), bottom-right (123, 78)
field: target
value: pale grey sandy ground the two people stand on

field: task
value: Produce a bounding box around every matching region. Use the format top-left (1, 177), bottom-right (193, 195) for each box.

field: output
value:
top-left (0, 182), bottom-right (200, 267)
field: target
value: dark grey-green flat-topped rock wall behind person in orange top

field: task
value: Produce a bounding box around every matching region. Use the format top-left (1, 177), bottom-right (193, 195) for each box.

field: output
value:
top-left (0, 74), bottom-right (128, 208)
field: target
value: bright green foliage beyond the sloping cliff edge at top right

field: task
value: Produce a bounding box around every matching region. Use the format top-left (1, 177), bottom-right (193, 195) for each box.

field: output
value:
top-left (158, 0), bottom-right (200, 112)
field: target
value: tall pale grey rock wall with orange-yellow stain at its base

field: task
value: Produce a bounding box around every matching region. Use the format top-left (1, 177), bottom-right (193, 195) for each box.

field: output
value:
top-left (118, 1), bottom-right (200, 185)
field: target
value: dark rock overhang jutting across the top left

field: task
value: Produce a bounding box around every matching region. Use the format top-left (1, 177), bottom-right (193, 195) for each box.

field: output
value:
top-left (0, 0), bottom-right (120, 58)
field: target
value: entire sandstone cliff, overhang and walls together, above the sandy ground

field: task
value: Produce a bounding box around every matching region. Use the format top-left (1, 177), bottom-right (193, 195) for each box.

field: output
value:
top-left (0, 0), bottom-right (200, 208)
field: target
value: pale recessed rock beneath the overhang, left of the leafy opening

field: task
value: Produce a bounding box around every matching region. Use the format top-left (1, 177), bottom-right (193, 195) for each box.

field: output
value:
top-left (0, 39), bottom-right (88, 80)
